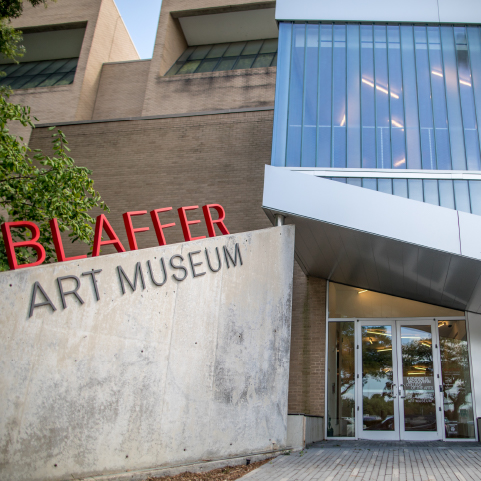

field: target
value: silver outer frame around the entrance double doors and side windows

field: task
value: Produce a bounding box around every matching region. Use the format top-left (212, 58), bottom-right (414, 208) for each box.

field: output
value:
top-left (324, 314), bottom-right (472, 442)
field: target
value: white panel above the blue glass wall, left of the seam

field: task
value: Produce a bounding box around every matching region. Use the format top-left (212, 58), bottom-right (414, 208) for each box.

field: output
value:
top-left (276, 0), bottom-right (438, 22)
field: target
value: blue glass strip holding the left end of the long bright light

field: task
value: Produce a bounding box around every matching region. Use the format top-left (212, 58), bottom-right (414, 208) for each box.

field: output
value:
top-left (361, 25), bottom-right (376, 169)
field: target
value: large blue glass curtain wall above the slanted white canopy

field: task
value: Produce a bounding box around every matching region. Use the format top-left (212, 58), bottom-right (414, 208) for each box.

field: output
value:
top-left (273, 22), bottom-right (481, 170)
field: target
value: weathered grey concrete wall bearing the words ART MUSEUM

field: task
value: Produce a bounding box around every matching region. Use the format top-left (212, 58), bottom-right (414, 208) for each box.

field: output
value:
top-left (0, 226), bottom-right (294, 481)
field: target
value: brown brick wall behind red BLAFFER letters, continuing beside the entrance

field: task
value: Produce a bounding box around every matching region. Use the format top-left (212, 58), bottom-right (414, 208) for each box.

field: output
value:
top-left (30, 111), bottom-right (326, 415)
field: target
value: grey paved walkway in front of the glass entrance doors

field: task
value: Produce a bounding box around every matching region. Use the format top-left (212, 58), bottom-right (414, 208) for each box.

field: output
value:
top-left (241, 441), bottom-right (481, 481)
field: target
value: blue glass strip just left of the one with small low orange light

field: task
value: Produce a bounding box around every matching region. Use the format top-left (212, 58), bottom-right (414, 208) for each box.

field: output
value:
top-left (317, 25), bottom-right (332, 167)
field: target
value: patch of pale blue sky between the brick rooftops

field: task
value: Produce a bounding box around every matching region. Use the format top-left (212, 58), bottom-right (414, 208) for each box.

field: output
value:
top-left (115, 0), bottom-right (162, 58)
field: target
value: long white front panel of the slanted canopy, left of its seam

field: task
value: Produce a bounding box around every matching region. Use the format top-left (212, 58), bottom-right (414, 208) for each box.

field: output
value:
top-left (263, 166), bottom-right (460, 254)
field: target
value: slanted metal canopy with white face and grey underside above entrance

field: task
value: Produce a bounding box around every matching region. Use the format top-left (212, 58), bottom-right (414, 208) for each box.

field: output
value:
top-left (263, 166), bottom-right (481, 313)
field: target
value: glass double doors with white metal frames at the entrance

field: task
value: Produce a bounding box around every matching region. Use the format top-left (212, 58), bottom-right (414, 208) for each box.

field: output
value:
top-left (356, 320), bottom-right (442, 440)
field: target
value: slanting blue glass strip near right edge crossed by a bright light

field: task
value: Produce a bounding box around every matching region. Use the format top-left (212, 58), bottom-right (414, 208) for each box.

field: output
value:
top-left (454, 27), bottom-right (480, 170)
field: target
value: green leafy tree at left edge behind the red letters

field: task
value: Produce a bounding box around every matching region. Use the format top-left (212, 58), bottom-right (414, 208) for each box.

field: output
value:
top-left (0, 0), bottom-right (108, 271)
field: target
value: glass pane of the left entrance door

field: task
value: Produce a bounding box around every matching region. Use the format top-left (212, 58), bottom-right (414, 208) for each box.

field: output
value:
top-left (361, 326), bottom-right (394, 431)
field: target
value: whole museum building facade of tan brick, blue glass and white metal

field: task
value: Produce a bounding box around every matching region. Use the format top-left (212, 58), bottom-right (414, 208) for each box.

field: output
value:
top-left (2, 0), bottom-right (481, 458)
